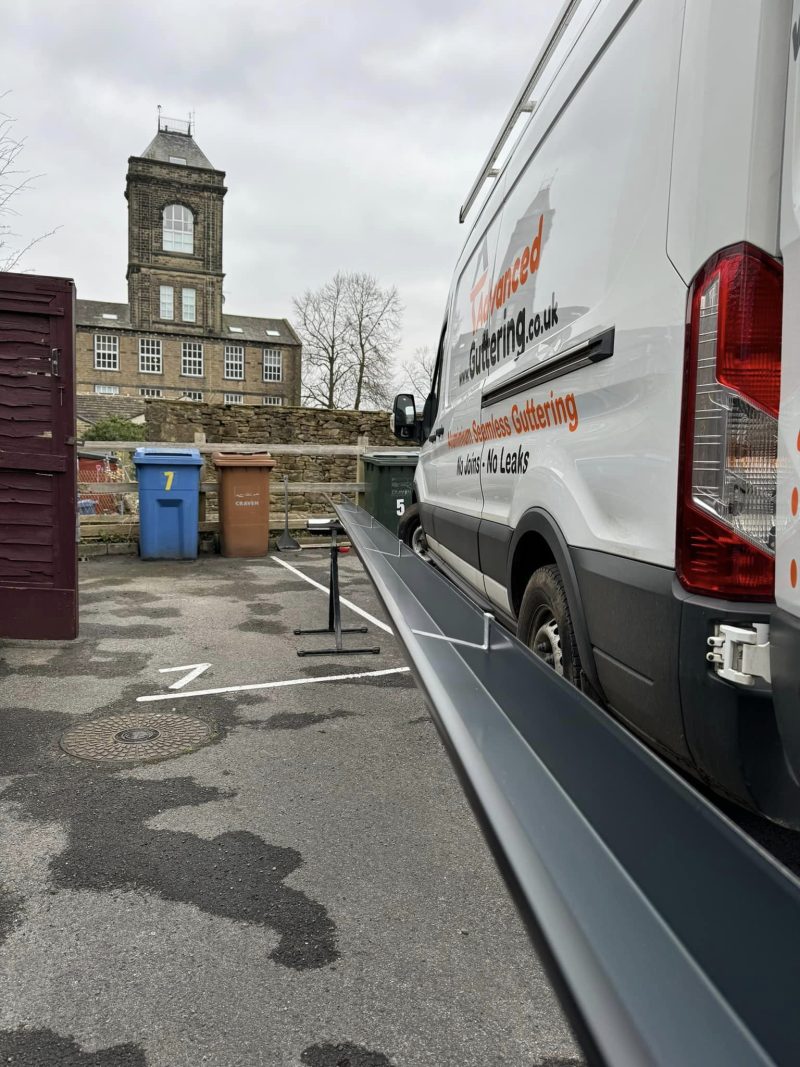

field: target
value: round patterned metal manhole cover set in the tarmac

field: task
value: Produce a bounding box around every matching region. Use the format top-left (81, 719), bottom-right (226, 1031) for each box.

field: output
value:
top-left (61, 712), bottom-right (212, 762)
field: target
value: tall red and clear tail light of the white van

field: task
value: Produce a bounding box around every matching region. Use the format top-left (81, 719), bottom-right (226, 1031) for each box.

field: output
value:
top-left (677, 244), bottom-right (783, 600)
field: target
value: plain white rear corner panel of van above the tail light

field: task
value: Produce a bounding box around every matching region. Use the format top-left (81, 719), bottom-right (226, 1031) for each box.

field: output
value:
top-left (667, 0), bottom-right (791, 284)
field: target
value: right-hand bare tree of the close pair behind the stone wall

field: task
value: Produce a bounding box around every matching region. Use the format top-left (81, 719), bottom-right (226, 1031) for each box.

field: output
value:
top-left (345, 273), bottom-right (402, 411)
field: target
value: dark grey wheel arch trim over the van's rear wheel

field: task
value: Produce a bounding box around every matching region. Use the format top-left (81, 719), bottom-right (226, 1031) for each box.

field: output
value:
top-left (506, 508), bottom-right (603, 700)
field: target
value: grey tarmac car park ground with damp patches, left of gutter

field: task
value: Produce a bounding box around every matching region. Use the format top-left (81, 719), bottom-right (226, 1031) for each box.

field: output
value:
top-left (0, 552), bottom-right (581, 1067)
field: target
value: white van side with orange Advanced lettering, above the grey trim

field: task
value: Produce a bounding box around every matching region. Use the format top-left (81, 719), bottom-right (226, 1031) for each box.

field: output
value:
top-left (438, 0), bottom-right (686, 577)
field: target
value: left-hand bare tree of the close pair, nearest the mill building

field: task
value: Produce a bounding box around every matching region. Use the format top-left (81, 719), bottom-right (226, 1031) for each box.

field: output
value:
top-left (292, 271), bottom-right (352, 408)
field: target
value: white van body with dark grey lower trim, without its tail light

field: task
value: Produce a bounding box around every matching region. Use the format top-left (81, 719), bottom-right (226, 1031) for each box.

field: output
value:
top-left (417, 0), bottom-right (800, 825)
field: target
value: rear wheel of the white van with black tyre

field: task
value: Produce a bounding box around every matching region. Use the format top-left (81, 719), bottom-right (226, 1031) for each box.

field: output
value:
top-left (516, 563), bottom-right (582, 688)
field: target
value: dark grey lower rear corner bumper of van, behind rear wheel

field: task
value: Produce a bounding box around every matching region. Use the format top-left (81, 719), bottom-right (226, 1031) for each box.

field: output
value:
top-left (571, 548), bottom-right (800, 827)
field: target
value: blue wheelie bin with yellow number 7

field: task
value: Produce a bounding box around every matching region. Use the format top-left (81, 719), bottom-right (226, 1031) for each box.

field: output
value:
top-left (133, 448), bottom-right (203, 559)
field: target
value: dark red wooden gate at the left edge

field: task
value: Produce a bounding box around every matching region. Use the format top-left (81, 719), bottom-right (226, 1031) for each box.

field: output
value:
top-left (0, 273), bottom-right (78, 638)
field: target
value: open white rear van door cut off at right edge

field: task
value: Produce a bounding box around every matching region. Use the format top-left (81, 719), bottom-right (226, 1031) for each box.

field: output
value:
top-left (770, 0), bottom-right (800, 780)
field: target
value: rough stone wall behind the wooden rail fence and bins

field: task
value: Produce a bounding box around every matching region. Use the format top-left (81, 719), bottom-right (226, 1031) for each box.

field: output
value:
top-left (145, 400), bottom-right (413, 515)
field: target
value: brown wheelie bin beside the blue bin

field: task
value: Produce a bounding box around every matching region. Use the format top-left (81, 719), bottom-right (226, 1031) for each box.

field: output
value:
top-left (212, 452), bottom-right (275, 558)
